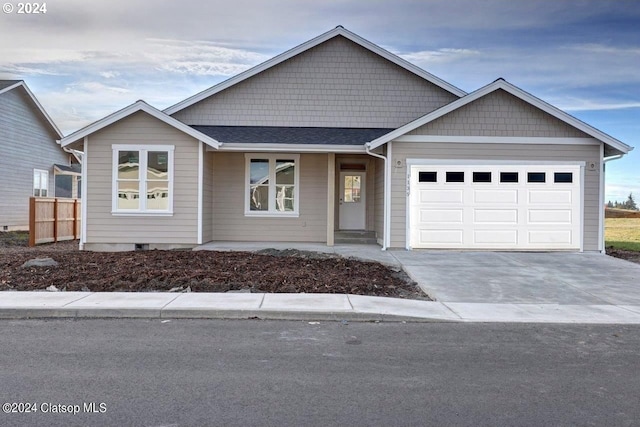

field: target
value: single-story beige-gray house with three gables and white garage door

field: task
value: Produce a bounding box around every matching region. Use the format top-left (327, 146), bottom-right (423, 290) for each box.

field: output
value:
top-left (61, 27), bottom-right (632, 251)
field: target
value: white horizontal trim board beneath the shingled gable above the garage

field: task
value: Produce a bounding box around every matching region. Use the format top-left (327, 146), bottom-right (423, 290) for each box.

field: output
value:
top-left (394, 135), bottom-right (602, 145)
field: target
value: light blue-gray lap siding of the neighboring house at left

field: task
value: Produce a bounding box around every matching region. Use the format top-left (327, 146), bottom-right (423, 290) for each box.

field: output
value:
top-left (0, 87), bottom-right (70, 230)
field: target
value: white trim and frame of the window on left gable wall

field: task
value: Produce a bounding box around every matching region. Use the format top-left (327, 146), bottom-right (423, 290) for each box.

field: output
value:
top-left (111, 144), bottom-right (175, 216)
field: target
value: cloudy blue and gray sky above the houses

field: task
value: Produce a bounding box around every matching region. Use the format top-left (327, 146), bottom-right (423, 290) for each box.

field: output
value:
top-left (0, 0), bottom-right (640, 201)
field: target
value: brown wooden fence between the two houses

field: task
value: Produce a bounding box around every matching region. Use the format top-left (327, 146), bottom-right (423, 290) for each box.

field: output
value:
top-left (29, 197), bottom-right (82, 246)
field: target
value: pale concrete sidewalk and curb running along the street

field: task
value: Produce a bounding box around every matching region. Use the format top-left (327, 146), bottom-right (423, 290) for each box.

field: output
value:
top-left (0, 292), bottom-right (640, 324)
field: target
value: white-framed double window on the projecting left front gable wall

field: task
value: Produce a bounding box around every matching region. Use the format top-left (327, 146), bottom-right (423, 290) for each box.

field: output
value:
top-left (112, 145), bottom-right (174, 214)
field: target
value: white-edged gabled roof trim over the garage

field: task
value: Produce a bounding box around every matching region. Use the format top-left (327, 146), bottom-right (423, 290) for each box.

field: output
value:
top-left (368, 79), bottom-right (633, 154)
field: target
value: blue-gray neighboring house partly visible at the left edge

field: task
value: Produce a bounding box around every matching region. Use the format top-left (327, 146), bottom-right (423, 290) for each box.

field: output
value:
top-left (0, 80), bottom-right (80, 231)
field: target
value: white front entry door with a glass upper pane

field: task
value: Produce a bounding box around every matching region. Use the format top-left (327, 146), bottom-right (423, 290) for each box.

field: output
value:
top-left (338, 171), bottom-right (366, 230)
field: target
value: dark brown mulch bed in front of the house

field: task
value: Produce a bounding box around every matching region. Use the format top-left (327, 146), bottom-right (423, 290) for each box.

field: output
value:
top-left (0, 234), bottom-right (429, 300)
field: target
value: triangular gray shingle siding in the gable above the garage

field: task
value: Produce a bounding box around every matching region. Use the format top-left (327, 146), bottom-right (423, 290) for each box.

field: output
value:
top-left (407, 89), bottom-right (589, 138)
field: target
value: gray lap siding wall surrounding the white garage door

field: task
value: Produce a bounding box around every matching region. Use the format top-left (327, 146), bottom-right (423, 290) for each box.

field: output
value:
top-left (391, 142), bottom-right (602, 251)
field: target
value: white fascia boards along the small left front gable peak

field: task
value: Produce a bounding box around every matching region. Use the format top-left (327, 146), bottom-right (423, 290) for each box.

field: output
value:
top-left (60, 101), bottom-right (220, 148)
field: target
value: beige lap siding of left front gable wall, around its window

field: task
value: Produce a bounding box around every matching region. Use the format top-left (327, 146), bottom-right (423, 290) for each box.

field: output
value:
top-left (82, 112), bottom-right (199, 250)
